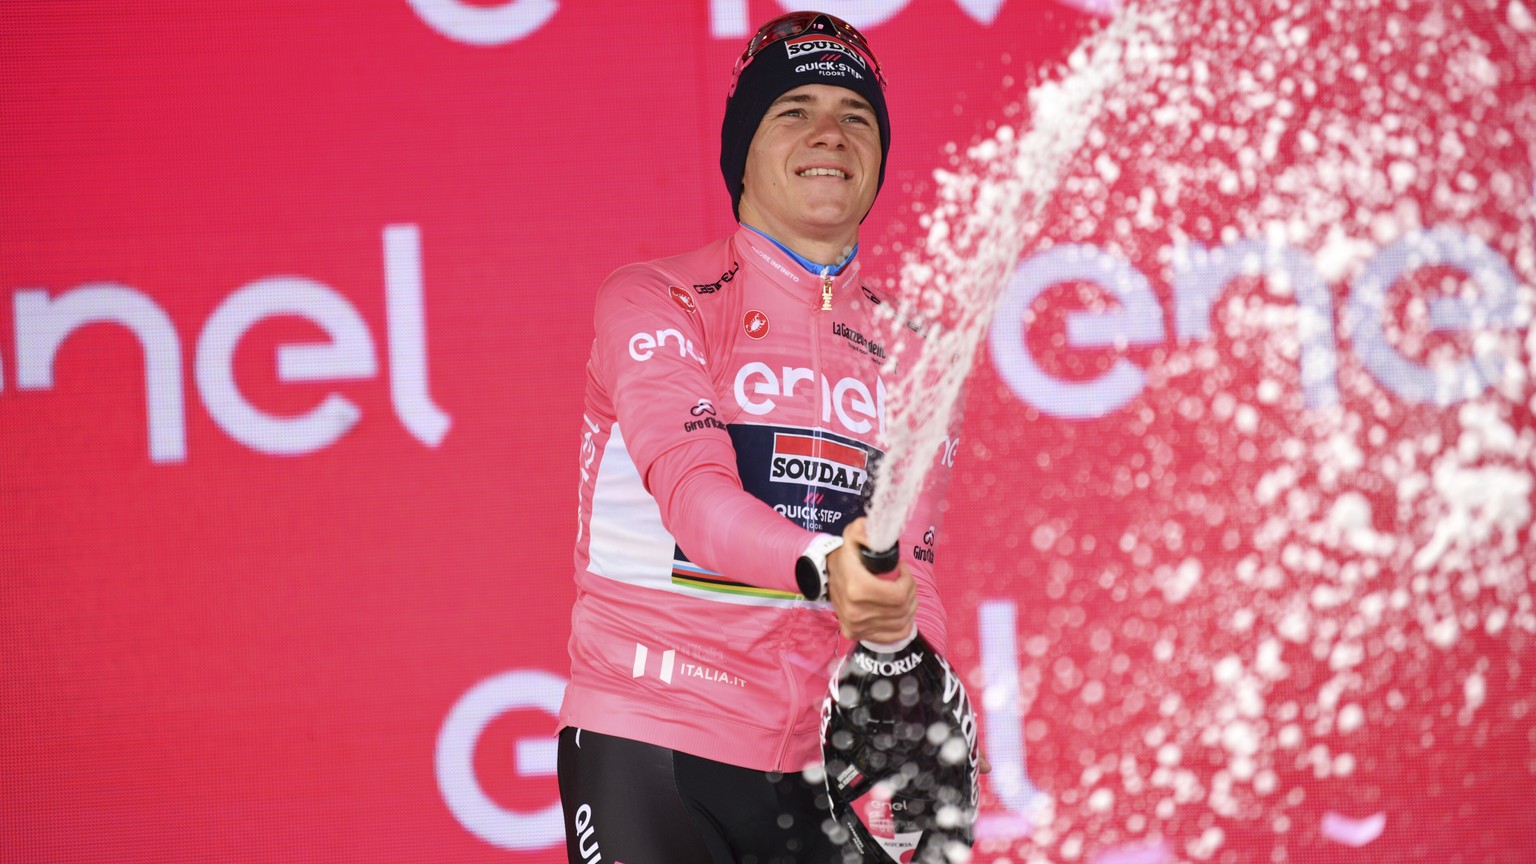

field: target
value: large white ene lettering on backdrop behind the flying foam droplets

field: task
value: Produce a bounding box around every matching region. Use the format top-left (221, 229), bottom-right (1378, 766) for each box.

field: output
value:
top-left (989, 226), bottom-right (1530, 420)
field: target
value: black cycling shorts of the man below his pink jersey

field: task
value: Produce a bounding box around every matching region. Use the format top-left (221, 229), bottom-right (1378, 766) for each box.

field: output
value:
top-left (559, 727), bottom-right (843, 864)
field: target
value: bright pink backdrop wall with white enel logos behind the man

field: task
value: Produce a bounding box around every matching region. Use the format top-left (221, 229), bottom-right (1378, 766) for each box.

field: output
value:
top-left (0, 0), bottom-right (1536, 864)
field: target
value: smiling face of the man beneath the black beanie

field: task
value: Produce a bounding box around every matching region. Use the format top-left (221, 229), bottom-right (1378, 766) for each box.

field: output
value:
top-left (740, 85), bottom-right (880, 263)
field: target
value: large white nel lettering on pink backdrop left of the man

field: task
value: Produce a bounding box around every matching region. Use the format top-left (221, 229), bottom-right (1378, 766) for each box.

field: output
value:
top-left (0, 224), bottom-right (452, 463)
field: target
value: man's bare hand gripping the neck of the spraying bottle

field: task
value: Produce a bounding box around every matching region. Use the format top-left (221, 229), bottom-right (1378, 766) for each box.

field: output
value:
top-left (826, 518), bottom-right (917, 643)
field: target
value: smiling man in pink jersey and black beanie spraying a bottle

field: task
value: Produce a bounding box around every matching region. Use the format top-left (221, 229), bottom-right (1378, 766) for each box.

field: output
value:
top-left (559, 12), bottom-right (945, 864)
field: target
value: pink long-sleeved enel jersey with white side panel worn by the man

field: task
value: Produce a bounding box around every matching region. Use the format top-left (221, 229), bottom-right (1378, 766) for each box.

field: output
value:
top-left (561, 228), bottom-right (948, 770)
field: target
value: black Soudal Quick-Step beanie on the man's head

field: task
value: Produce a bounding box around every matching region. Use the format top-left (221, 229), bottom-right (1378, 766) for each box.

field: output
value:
top-left (720, 15), bottom-right (891, 218)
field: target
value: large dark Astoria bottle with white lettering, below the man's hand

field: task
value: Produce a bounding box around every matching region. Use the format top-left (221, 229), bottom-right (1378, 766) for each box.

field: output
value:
top-left (822, 621), bottom-right (980, 864)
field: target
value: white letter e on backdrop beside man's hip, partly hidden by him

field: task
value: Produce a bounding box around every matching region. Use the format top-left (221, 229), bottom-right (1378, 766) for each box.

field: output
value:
top-left (436, 669), bottom-right (565, 852)
